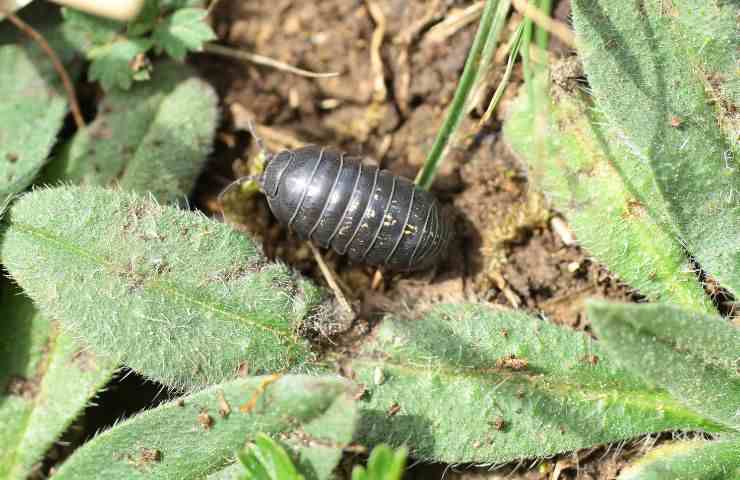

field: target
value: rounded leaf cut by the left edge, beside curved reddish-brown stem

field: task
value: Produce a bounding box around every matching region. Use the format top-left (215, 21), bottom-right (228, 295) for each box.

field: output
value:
top-left (0, 26), bottom-right (69, 210)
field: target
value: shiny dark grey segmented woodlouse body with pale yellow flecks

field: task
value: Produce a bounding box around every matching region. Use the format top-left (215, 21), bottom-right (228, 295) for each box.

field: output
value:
top-left (250, 145), bottom-right (453, 271)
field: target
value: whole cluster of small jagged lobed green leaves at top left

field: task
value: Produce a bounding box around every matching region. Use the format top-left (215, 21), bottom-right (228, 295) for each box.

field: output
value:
top-left (63, 0), bottom-right (216, 90)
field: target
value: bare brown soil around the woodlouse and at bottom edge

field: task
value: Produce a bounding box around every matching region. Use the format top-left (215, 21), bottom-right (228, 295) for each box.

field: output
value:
top-left (193, 0), bottom-right (632, 478)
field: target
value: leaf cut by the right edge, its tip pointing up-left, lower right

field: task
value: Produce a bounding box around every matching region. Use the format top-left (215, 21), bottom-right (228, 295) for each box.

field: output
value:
top-left (588, 302), bottom-right (740, 430)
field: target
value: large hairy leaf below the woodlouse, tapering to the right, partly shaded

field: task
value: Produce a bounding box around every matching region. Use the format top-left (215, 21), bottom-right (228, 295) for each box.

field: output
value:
top-left (352, 304), bottom-right (727, 463)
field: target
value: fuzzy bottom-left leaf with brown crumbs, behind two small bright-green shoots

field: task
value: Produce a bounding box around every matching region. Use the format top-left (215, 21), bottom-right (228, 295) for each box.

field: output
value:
top-left (52, 376), bottom-right (356, 480)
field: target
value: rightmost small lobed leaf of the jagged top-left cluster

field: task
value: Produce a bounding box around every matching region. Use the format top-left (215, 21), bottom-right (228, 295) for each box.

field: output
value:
top-left (152, 8), bottom-right (216, 61)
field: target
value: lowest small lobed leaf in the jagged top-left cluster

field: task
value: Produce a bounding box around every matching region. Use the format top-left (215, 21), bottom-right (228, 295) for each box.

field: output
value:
top-left (87, 38), bottom-right (153, 90)
